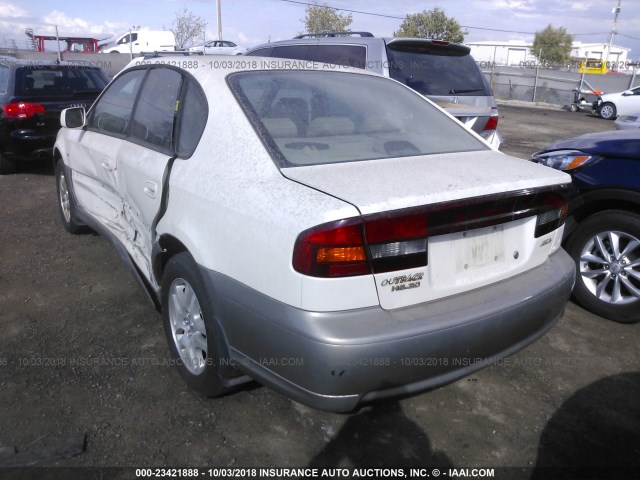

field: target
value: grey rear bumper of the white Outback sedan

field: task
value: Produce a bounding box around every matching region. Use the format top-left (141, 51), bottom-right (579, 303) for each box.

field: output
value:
top-left (202, 250), bottom-right (575, 412)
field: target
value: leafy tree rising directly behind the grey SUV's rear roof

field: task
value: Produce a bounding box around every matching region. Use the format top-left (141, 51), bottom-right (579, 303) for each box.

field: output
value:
top-left (393, 7), bottom-right (469, 43)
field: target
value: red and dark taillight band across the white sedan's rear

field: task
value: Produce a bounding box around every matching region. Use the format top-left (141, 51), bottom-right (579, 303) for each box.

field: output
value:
top-left (293, 187), bottom-right (567, 278)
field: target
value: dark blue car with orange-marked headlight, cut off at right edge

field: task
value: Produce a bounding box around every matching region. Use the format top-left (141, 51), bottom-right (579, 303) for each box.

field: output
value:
top-left (531, 130), bottom-right (640, 323)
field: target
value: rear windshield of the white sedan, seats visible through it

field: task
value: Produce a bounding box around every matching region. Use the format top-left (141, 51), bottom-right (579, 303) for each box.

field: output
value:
top-left (229, 71), bottom-right (488, 167)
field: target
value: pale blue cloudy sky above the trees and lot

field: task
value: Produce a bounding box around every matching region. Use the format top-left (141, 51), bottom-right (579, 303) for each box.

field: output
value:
top-left (0, 0), bottom-right (640, 59)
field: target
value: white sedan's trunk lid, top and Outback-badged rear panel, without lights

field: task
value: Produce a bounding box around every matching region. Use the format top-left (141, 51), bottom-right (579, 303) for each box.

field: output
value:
top-left (281, 150), bottom-right (571, 309)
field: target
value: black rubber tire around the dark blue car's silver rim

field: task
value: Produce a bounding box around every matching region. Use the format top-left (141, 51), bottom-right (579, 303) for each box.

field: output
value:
top-left (566, 210), bottom-right (640, 323)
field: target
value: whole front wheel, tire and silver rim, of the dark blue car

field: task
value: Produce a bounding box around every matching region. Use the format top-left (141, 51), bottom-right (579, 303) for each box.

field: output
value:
top-left (566, 210), bottom-right (640, 323)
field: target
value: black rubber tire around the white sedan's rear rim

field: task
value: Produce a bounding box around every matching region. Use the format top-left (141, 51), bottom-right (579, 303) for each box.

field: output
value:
top-left (162, 252), bottom-right (229, 397)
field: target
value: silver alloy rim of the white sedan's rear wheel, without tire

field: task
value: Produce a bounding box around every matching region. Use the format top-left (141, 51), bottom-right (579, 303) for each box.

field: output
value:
top-left (168, 278), bottom-right (207, 375)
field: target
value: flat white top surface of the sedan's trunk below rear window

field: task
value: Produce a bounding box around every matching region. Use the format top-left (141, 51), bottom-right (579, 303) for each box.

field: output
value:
top-left (282, 150), bottom-right (571, 214)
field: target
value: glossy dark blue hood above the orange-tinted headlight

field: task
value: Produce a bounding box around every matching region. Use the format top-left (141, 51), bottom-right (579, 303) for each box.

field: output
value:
top-left (543, 129), bottom-right (640, 158)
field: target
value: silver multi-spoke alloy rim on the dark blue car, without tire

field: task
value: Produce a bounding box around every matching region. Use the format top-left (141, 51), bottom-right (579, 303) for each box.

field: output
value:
top-left (580, 231), bottom-right (640, 308)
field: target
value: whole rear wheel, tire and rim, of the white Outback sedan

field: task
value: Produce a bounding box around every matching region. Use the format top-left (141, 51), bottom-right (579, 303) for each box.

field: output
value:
top-left (161, 253), bottom-right (234, 397)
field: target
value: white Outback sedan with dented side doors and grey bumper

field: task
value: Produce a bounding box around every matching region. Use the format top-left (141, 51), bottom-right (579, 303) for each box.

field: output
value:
top-left (55, 57), bottom-right (575, 412)
